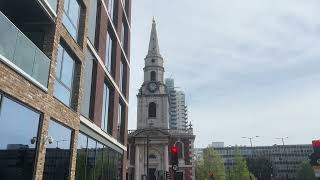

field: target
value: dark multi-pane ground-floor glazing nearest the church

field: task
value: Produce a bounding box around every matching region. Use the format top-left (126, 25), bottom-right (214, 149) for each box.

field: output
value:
top-left (76, 133), bottom-right (123, 180)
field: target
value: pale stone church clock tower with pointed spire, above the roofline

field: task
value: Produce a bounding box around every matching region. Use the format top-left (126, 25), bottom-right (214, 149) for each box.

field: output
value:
top-left (137, 20), bottom-right (169, 129)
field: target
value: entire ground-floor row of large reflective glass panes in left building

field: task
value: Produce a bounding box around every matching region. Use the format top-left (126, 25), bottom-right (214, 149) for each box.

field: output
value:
top-left (0, 93), bottom-right (123, 180)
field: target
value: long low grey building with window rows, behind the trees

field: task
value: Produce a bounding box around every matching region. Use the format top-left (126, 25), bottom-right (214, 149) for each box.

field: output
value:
top-left (195, 144), bottom-right (313, 180)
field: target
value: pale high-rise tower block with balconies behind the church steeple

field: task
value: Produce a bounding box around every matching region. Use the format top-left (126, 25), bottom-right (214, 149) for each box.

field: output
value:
top-left (165, 78), bottom-right (188, 129)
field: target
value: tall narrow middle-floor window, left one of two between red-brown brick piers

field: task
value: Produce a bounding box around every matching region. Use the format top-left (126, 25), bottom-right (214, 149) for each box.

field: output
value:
top-left (101, 82), bottom-right (113, 134)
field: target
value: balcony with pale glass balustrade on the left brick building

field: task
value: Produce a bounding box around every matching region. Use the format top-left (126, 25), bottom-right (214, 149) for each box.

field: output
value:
top-left (0, 3), bottom-right (50, 90)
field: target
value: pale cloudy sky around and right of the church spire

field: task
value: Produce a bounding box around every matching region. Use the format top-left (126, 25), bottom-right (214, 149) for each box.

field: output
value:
top-left (129, 0), bottom-right (320, 147)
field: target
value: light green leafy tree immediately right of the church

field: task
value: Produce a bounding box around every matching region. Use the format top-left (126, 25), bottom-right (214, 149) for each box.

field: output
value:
top-left (196, 148), bottom-right (226, 180)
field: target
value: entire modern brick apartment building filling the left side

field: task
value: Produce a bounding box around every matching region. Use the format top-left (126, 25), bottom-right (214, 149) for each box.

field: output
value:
top-left (0, 0), bottom-right (131, 180)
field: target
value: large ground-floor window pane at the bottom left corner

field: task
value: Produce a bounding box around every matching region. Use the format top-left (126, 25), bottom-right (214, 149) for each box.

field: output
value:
top-left (0, 94), bottom-right (41, 180)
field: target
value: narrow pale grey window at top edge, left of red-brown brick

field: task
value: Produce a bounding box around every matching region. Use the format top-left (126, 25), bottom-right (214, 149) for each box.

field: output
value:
top-left (88, 0), bottom-right (98, 45)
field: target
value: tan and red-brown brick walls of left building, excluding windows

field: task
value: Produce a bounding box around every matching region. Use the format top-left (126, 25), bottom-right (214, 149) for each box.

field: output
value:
top-left (0, 0), bottom-right (131, 180)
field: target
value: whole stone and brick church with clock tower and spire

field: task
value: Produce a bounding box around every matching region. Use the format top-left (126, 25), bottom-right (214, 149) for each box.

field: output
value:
top-left (127, 20), bottom-right (195, 180)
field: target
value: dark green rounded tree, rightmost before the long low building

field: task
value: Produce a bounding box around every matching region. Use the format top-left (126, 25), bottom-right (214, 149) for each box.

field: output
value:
top-left (247, 156), bottom-right (273, 180)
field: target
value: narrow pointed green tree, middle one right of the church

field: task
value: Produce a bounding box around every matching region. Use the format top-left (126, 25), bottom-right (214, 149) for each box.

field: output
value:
top-left (228, 149), bottom-right (254, 180)
